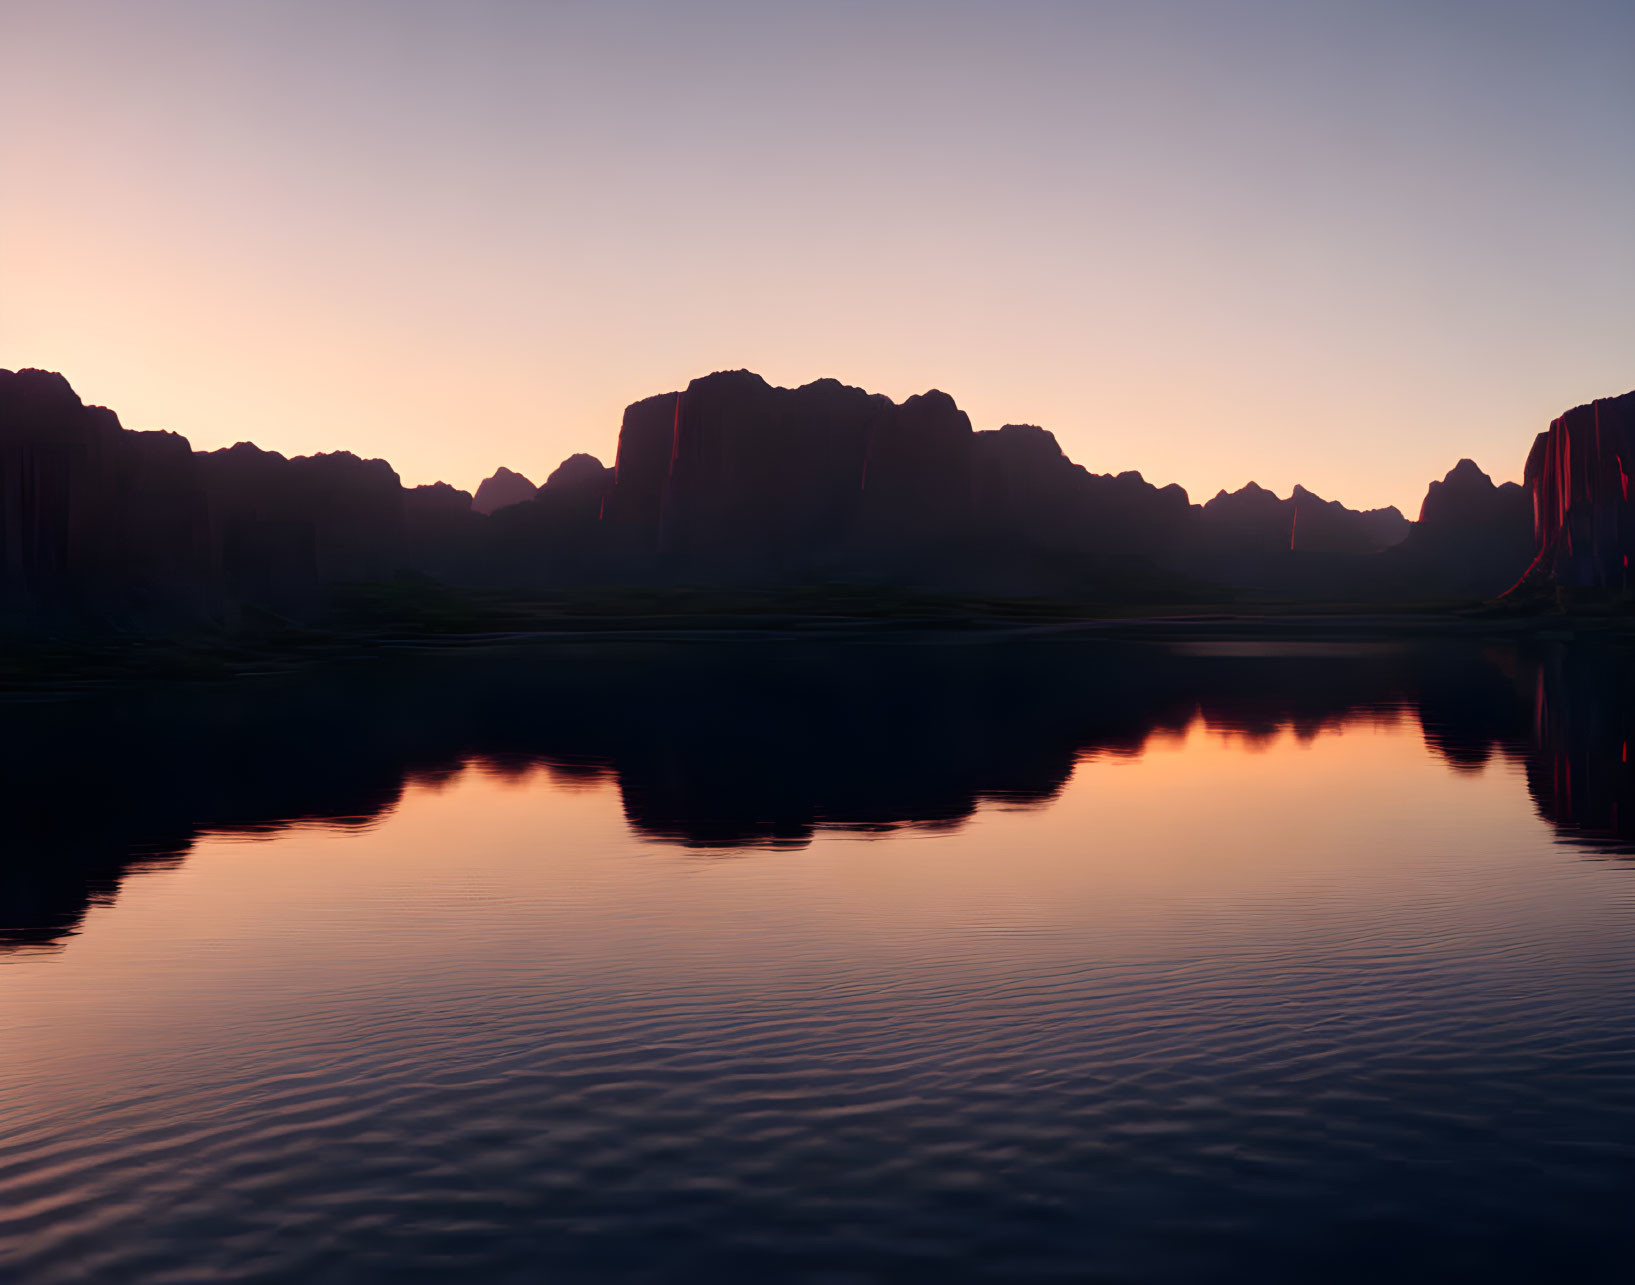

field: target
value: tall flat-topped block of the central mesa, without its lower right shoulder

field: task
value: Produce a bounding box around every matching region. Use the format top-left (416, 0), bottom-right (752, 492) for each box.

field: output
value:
top-left (603, 371), bottom-right (971, 582)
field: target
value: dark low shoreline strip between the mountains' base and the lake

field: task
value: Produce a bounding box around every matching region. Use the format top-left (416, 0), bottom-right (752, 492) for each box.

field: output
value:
top-left (0, 579), bottom-right (1635, 693)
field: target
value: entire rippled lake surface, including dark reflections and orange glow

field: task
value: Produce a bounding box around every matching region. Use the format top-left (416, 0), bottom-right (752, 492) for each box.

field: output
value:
top-left (0, 644), bottom-right (1635, 1282)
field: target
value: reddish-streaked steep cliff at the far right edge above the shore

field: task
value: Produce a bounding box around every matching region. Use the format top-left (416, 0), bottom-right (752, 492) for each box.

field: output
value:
top-left (1525, 392), bottom-right (1635, 590)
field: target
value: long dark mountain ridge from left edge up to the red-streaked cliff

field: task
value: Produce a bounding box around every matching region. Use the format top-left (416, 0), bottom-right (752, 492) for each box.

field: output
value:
top-left (0, 369), bottom-right (1563, 628)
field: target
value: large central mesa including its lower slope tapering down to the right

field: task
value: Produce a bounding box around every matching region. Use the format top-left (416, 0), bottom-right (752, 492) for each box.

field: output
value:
top-left (602, 371), bottom-right (1187, 592)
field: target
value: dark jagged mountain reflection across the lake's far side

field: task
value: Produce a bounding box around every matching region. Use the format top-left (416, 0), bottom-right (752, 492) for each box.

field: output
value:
top-left (0, 643), bottom-right (1635, 948)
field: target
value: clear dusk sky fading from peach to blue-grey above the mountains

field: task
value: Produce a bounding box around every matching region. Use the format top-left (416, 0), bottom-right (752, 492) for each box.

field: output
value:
top-left (0, 0), bottom-right (1635, 517)
